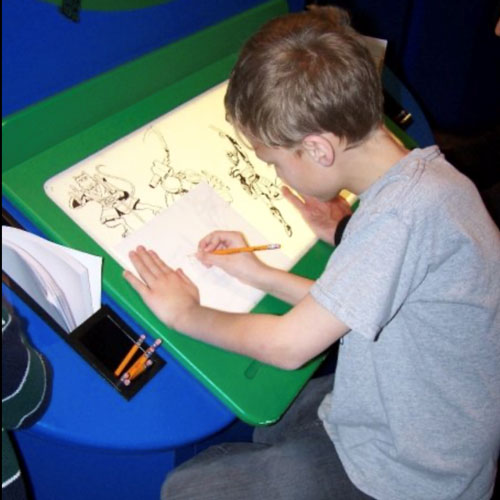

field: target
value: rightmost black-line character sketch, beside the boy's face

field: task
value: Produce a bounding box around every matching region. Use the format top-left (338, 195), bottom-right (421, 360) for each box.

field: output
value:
top-left (212, 127), bottom-right (293, 236)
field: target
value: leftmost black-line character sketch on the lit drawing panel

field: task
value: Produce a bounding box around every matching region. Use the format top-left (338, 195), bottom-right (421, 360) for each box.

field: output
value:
top-left (69, 165), bottom-right (161, 237)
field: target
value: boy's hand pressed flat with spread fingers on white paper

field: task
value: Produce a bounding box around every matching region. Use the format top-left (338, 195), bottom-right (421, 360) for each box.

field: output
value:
top-left (123, 246), bottom-right (200, 329)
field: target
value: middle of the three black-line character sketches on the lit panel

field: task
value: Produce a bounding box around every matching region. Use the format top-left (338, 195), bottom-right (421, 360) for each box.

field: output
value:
top-left (143, 127), bottom-right (233, 207)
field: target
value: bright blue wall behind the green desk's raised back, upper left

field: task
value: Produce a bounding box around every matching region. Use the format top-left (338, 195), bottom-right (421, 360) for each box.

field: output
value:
top-left (2, 0), bottom-right (304, 116)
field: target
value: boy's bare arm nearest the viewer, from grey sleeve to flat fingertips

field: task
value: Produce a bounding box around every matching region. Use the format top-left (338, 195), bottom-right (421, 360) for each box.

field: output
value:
top-left (125, 249), bottom-right (348, 369)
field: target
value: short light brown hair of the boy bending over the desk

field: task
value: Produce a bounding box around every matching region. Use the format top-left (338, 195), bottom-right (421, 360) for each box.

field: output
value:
top-left (225, 7), bottom-right (383, 148)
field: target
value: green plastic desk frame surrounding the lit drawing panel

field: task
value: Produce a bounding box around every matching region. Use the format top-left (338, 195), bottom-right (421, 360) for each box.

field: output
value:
top-left (2, 1), bottom-right (332, 425)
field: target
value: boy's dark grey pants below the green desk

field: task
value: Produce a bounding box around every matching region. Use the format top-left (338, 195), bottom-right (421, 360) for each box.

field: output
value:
top-left (161, 376), bottom-right (371, 500)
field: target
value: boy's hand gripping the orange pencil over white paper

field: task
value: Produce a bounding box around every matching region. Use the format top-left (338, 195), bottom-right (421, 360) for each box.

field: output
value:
top-left (196, 231), bottom-right (268, 288)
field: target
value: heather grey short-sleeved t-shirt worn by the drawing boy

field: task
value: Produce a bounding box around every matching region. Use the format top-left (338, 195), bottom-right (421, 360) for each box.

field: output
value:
top-left (311, 147), bottom-right (500, 500)
